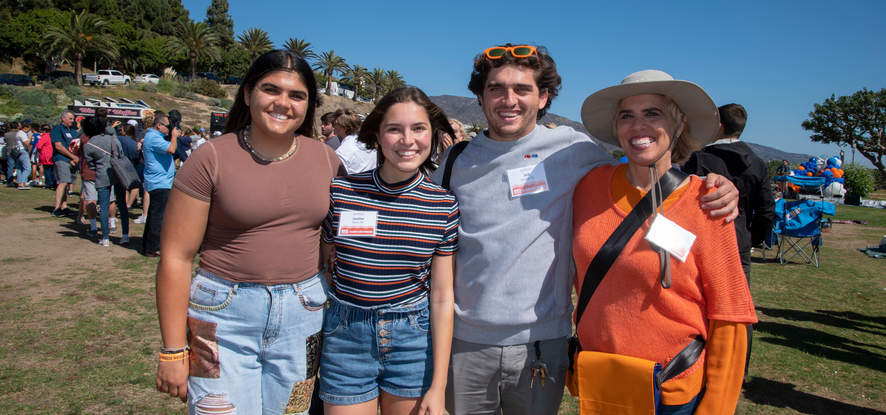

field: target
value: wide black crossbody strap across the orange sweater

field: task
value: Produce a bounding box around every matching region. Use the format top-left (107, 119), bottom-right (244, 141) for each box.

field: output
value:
top-left (575, 168), bottom-right (687, 327)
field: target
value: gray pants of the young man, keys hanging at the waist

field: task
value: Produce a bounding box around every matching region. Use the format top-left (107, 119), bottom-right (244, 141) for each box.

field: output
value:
top-left (446, 337), bottom-right (569, 415)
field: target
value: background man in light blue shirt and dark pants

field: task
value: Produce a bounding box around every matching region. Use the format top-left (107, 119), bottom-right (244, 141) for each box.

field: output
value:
top-left (142, 112), bottom-right (181, 256)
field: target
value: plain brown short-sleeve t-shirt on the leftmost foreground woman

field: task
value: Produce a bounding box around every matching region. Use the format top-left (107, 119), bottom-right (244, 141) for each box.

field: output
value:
top-left (173, 133), bottom-right (341, 284)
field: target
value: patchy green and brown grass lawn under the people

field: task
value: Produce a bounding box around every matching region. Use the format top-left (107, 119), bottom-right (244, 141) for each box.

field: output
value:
top-left (0, 188), bottom-right (886, 414)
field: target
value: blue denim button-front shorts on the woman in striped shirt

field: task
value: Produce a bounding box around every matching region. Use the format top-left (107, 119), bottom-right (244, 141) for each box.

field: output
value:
top-left (320, 295), bottom-right (434, 405)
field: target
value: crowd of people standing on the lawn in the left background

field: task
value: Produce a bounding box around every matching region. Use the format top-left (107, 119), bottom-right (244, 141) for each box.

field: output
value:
top-left (0, 108), bottom-right (219, 250)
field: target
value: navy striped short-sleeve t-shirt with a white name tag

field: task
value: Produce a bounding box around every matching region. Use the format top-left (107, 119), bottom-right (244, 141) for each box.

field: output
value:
top-left (323, 169), bottom-right (459, 307)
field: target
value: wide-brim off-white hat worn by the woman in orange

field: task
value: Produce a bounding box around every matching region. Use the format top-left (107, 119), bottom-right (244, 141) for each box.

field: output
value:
top-left (581, 69), bottom-right (720, 147)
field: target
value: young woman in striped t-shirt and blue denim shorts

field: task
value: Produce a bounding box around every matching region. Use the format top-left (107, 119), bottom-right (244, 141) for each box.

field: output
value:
top-left (320, 87), bottom-right (459, 415)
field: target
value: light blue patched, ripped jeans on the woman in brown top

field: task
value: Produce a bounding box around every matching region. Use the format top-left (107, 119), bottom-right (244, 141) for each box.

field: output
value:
top-left (188, 270), bottom-right (327, 415)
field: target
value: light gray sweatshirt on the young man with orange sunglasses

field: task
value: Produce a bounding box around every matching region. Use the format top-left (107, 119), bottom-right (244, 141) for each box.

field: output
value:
top-left (433, 126), bottom-right (613, 346)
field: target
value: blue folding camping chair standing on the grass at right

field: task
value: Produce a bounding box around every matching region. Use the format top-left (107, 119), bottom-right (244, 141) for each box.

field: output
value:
top-left (773, 199), bottom-right (836, 268)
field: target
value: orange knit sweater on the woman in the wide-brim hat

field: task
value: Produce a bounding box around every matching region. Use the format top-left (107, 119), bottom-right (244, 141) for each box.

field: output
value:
top-left (573, 165), bottom-right (757, 408)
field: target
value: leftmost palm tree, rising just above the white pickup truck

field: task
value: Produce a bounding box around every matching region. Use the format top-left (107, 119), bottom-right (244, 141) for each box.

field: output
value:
top-left (45, 10), bottom-right (117, 85)
